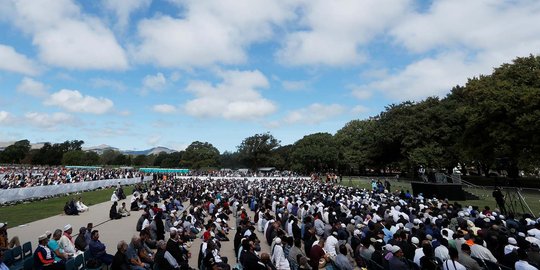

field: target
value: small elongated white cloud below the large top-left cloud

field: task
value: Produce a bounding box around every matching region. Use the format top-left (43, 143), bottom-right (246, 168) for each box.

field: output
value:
top-left (44, 89), bottom-right (114, 114)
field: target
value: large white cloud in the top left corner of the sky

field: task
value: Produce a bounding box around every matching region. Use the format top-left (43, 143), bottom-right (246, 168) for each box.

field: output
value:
top-left (3, 0), bottom-right (128, 70)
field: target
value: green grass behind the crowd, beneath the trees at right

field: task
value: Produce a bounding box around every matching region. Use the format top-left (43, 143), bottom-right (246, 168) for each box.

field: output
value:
top-left (342, 177), bottom-right (540, 216)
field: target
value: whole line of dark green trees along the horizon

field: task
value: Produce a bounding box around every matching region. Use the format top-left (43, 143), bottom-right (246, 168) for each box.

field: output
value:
top-left (0, 55), bottom-right (540, 177)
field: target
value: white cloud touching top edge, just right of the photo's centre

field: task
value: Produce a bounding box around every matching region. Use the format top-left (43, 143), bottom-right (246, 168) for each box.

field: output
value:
top-left (277, 0), bottom-right (411, 66)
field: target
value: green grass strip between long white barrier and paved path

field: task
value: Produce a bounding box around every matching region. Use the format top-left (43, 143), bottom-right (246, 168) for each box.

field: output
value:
top-left (0, 187), bottom-right (133, 227)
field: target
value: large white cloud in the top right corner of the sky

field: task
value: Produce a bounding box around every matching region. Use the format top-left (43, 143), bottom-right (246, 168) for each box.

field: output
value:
top-left (391, 0), bottom-right (540, 54)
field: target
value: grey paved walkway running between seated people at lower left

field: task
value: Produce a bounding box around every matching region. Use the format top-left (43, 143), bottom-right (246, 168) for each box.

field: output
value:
top-left (8, 196), bottom-right (269, 268)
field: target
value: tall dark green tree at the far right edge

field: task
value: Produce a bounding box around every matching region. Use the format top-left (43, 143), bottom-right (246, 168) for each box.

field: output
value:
top-left (458, 56), bottom-right (540, 177)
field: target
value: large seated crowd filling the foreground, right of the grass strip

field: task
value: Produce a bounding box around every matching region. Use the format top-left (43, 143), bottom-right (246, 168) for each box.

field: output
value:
top-left (3, 177), bottom-right (540, 270)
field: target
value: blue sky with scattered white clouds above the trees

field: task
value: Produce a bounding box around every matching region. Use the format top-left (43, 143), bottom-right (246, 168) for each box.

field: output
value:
top-left (0, 0), bottom-right (540, 151)
